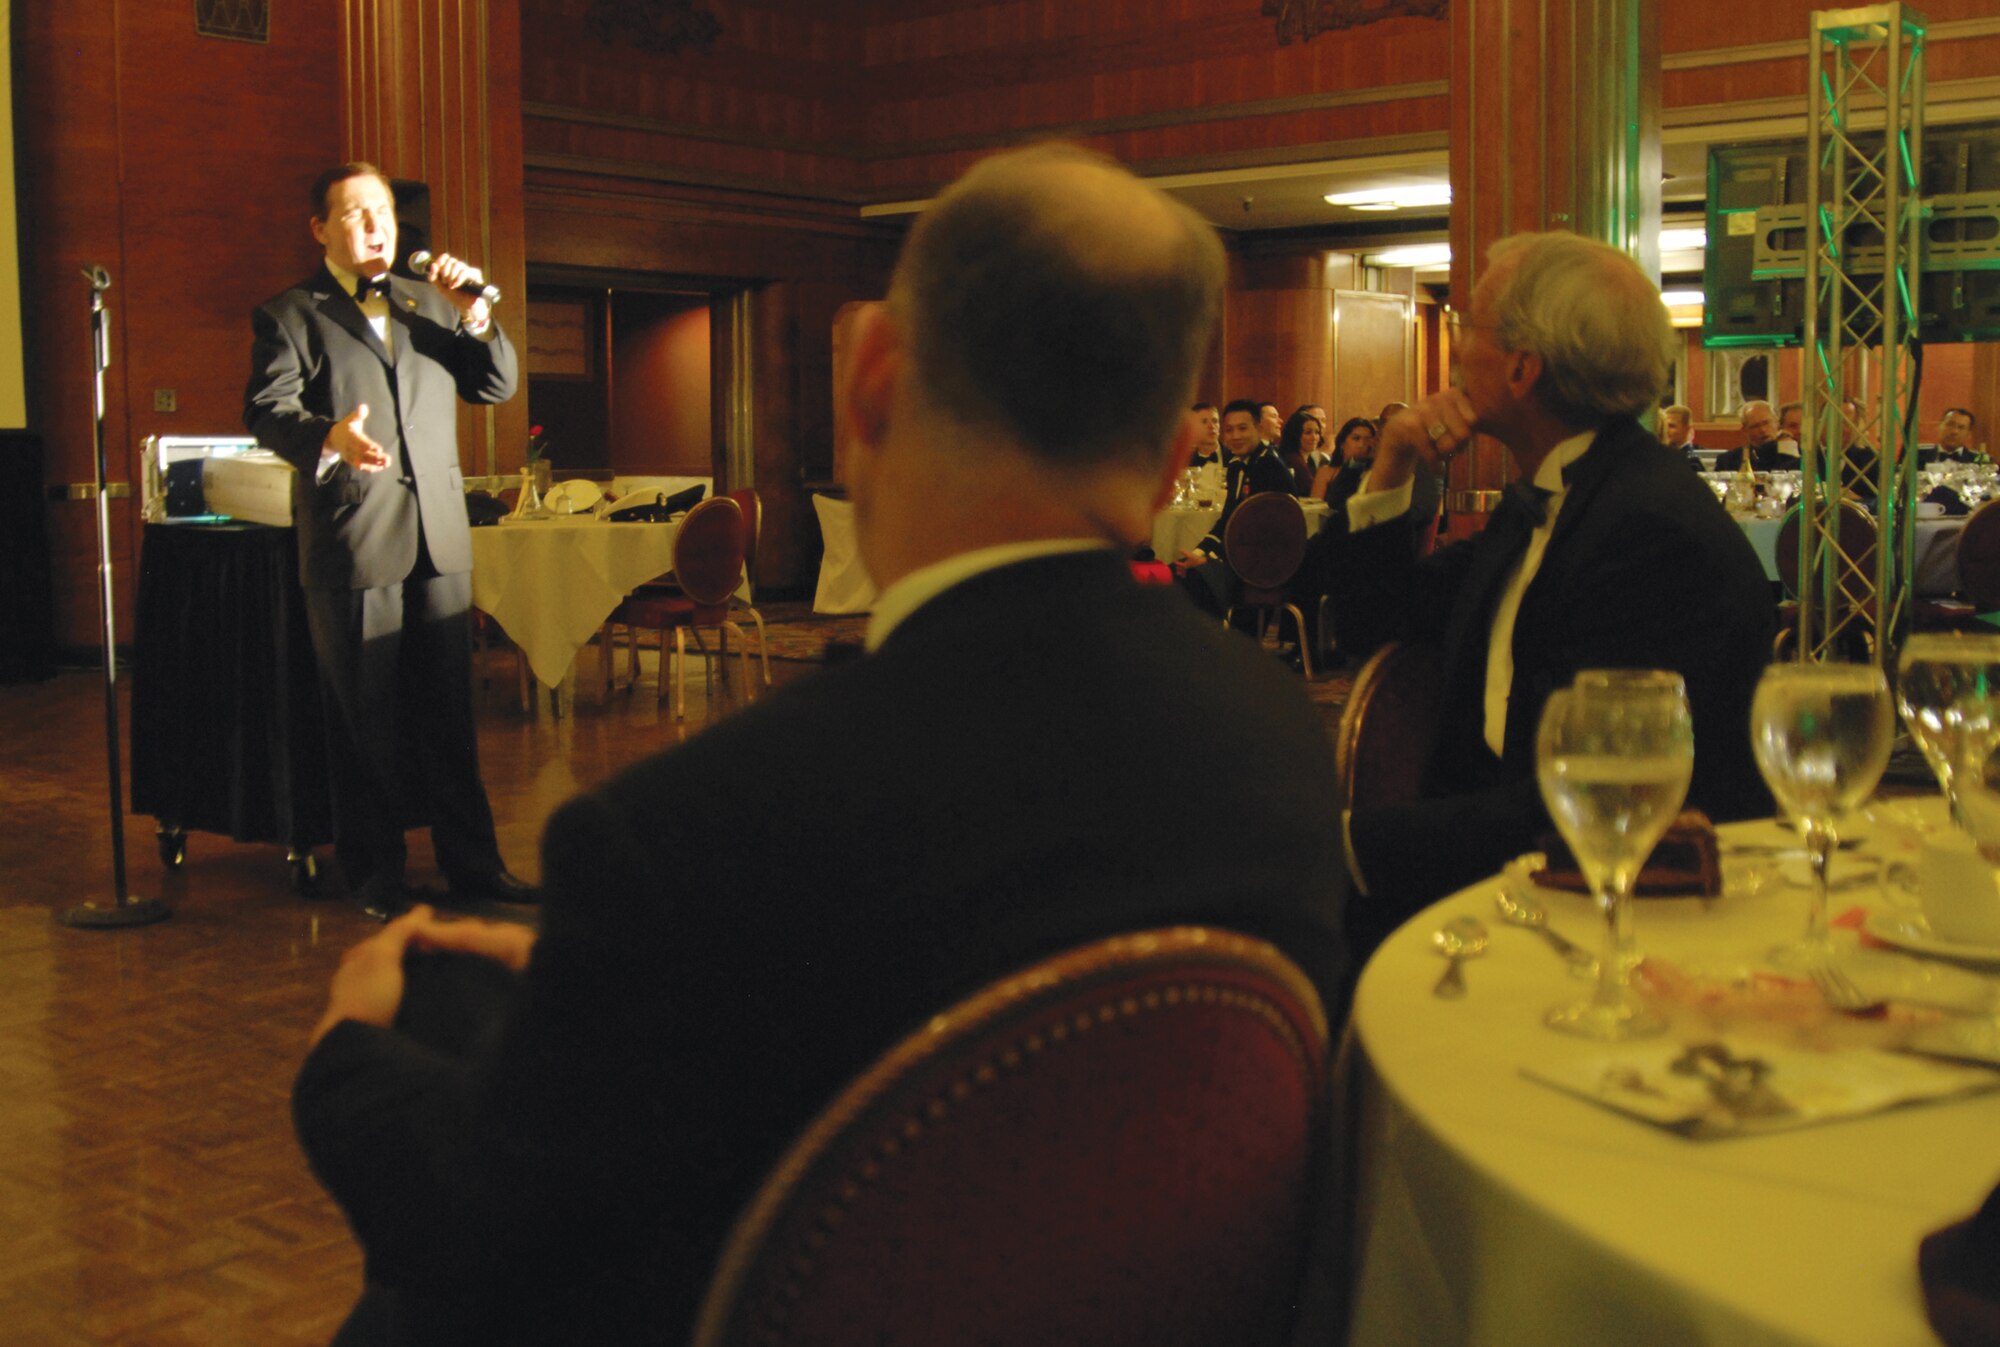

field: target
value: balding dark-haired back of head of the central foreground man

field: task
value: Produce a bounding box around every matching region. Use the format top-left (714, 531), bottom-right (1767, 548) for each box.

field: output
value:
top-left (888, 146), bottom-right (1224, 468)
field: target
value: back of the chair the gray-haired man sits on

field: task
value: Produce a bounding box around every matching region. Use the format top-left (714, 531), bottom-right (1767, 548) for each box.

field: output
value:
top-left (1334, 642), bottom-right (1444, 809)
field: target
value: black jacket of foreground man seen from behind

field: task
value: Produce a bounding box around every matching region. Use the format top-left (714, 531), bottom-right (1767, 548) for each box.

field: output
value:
top-left (294, 552), bottom-right (1346, 1343)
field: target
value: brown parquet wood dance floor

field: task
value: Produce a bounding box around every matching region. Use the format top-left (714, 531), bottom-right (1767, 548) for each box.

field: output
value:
top-left (0, 656), bottom-right (816, 1347)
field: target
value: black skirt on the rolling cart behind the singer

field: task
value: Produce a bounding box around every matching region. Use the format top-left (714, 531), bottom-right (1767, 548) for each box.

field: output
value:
top-left (132, 524), bottom-right (332, 849)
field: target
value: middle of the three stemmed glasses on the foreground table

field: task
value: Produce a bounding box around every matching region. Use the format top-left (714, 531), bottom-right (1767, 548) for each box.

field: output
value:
top-left (1750, 664), bottom-right (1896, 967)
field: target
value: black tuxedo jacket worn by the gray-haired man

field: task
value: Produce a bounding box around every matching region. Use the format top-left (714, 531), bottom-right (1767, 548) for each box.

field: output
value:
top-left (1328, 418), bottom-right (1774, 939)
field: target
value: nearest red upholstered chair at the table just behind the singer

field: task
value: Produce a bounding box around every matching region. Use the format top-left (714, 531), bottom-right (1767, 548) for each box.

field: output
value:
top-left (604, 496), bottom-right (750, 719)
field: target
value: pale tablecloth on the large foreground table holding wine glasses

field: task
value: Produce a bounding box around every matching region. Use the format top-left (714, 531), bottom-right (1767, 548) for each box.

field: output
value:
top-left (1348, 803), bottom-right (2000, 1347)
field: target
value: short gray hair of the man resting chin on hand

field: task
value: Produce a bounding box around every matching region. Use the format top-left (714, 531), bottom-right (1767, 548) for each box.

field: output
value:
top-left (1488, 232), bottom-right (1676, 426)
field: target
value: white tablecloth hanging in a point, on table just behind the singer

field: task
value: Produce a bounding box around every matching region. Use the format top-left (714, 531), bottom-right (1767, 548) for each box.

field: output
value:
top-left (472, 518), bottom-right (680, 687)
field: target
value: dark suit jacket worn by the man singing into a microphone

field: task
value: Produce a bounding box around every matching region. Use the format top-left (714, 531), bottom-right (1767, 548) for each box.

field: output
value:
top-left (244, 266), bottom-right (520, 590)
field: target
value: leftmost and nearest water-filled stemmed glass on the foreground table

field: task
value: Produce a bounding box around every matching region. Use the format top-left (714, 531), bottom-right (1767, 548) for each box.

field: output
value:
top-left (1534, 670), bottom-right (1694, 1041)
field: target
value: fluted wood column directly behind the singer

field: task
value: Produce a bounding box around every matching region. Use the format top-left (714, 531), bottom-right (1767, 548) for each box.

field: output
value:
top-left (340, 0), bottom-right (528, 474)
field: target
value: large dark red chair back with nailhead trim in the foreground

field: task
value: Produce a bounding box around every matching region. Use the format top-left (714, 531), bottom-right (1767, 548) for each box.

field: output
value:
top-left (694, 927), bottom-right (1326, 1347)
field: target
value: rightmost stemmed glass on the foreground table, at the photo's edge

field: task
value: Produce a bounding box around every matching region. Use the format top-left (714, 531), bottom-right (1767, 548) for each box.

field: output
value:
top-left (1896, 632), bottom-right (2000, 827)
